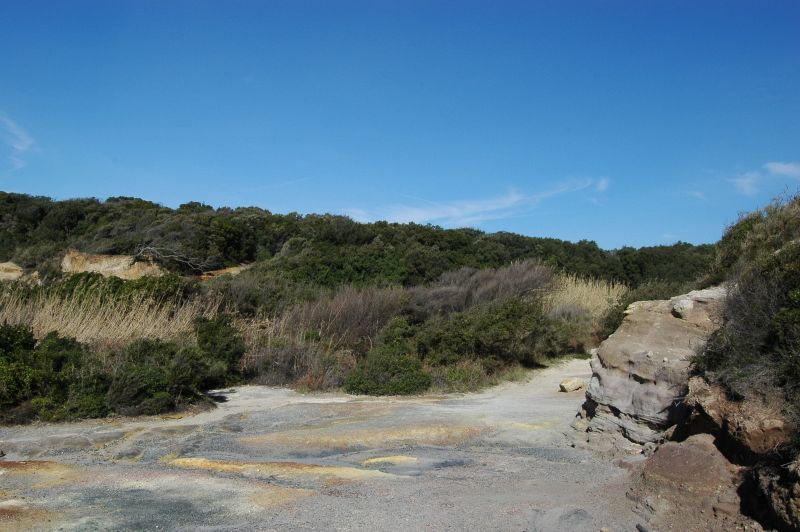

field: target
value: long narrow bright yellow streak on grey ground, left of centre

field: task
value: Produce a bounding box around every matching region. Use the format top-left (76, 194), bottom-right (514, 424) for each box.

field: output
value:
top-left (166, 458), bottom-right (395, 481)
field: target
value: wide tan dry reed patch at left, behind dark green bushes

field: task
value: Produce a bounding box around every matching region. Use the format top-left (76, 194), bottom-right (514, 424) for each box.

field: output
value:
top-left (0, 290), bottom-right (220, 346)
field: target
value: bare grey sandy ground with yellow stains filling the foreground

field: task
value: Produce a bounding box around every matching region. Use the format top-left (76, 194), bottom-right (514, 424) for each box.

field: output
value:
top-left (0, 360), bottom-right (641, 531)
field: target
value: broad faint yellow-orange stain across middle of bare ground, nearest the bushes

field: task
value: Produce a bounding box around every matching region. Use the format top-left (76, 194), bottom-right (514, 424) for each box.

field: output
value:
top-left (239, 424), bottom-right (487, 449)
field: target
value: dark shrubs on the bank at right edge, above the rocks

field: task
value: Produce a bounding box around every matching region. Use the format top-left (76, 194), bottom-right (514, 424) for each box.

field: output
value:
top-left (696, 196), bottom-right (800, 447)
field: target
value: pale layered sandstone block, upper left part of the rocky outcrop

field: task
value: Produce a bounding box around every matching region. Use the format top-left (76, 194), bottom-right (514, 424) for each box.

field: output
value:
top-left (582, 287), bottom-right (726, 443)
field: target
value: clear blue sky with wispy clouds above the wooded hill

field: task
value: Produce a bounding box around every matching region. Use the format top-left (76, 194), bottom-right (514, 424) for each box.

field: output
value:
top-left (0, 0), bottom-right (800, 248)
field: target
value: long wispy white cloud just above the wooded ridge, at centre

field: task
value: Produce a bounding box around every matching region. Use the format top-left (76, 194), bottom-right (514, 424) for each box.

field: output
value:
top-left (344, 179), bottom-right (597, 227)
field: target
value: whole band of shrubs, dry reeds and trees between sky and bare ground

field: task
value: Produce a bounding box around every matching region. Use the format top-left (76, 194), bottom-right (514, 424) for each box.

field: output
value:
top-left (0, 193), bottom-right (713, 422)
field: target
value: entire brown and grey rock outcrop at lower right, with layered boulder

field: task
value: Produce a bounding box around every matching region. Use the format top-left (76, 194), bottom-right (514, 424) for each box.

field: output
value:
top-left (573, 288), bottom-right (800, 530)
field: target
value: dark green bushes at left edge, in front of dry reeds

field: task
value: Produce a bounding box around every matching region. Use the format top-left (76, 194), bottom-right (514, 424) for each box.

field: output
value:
top-left (0, 315), bottom-right (244, 423)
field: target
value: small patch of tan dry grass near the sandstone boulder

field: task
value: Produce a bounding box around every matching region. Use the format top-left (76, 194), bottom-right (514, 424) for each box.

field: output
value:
top-left (545, 275), bottom-right (628, 326)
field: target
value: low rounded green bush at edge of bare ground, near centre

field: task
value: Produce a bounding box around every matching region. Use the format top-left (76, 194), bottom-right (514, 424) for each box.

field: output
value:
top-left (344, 346), bottom-right (431, 395)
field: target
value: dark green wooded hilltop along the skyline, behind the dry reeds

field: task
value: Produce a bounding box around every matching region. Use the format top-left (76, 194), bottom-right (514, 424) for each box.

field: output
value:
top-left (0, 192), bottom-right (712, 287)
